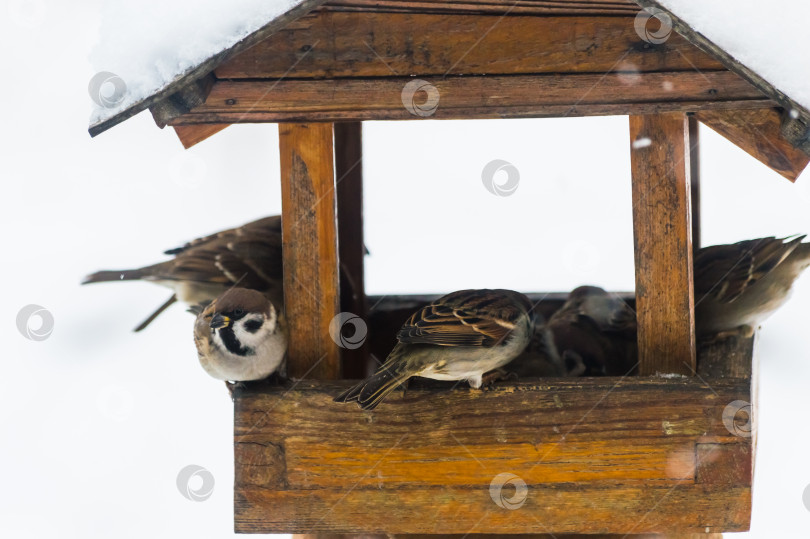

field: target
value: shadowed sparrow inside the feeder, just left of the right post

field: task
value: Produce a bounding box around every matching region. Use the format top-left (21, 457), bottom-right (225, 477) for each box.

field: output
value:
top-left (548, 286), bottom-right (638, 376)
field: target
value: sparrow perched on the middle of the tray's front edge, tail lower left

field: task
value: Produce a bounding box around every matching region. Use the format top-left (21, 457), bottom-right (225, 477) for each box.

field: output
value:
top-left (335, 290), bottom-right (534, 410)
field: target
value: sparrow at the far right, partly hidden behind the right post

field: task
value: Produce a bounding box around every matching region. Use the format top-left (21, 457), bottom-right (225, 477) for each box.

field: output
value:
top-left (694, 236), bottom-right (810, 341)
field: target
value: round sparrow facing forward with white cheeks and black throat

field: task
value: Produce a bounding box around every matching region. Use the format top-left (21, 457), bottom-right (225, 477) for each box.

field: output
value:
top-left (194, 288), bottom-right (287, 382)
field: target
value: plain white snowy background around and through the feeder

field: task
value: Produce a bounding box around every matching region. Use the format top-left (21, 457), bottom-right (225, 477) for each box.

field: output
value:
top-left (0, 0), bottom-right (810, 539)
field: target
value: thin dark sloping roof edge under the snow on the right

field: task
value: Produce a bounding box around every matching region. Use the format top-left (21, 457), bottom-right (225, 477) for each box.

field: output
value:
top-left (633, 0), bottom-right (810, 141)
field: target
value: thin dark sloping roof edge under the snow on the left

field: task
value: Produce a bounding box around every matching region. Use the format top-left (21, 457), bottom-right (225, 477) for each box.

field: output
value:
top-left (87, 0), bottom-right (326, 137)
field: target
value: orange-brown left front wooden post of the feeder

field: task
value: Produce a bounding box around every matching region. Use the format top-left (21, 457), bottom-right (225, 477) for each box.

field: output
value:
top-left (279, 124), bottom-right (340, 379)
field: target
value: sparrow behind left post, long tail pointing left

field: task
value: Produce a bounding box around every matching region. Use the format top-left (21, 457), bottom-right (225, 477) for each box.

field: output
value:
top-left (82, 215), bottom-right (284, 331)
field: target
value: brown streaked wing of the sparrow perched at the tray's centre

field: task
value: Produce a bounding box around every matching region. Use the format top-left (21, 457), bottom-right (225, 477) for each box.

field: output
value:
top-left (397, 290), bottom-right (532, 346)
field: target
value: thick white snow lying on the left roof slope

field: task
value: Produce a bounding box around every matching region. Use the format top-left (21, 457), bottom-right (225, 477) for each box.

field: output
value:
top-left (89, 0), bottom-right (301, 124)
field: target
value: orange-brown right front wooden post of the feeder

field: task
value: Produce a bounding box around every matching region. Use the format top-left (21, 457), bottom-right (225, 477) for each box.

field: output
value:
top-left (630, 114), bottom-right (696, 375)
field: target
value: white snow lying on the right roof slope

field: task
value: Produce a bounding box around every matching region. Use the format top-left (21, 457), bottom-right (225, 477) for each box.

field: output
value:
top-left (658, 0), bottom-right (810, 109)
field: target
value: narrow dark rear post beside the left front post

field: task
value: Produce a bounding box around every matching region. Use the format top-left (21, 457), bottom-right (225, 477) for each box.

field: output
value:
top-left (335, 122), bottom-right (369, 378)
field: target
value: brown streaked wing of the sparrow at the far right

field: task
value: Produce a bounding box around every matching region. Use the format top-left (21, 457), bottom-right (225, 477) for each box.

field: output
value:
top-left (694, 236), bottom-right (804, 303)
